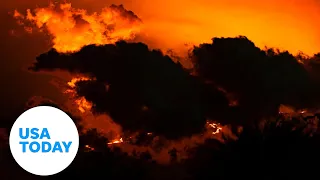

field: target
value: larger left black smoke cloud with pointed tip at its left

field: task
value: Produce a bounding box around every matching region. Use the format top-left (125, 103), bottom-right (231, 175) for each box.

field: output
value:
top-left (31, 41), bottom-right (232, 138)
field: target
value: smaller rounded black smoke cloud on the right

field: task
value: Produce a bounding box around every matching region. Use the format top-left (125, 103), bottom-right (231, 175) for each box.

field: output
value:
top-left (192, 36), bottom-right (320, 122)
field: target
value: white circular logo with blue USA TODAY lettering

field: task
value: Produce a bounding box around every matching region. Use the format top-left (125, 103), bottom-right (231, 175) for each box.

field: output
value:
top-left (9, 106), bottom-right (79, 176)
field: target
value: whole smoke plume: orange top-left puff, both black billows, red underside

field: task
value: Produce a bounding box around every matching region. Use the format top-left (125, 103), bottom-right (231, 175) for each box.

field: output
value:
top-left (14, 1), bottom-right (320, 165)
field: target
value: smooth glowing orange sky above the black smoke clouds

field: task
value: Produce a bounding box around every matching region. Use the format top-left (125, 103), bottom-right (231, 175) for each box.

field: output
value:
top-left (7, 0), bottom-right (320, 54)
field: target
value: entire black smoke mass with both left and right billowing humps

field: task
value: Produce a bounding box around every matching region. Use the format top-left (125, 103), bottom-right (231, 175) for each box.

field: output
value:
top-left (26, 37), bottom-right (319, 138)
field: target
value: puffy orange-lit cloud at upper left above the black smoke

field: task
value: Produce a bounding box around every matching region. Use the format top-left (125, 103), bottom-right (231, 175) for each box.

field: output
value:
top-left (13, 3), bottom-right (140, 52)
